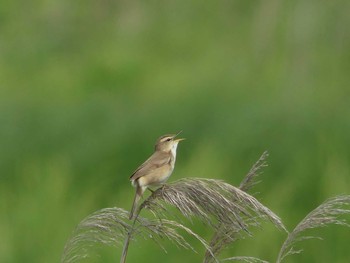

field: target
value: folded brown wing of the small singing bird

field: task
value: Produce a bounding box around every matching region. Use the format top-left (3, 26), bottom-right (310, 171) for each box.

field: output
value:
top-left (130, 151), bottom-right (170, 181)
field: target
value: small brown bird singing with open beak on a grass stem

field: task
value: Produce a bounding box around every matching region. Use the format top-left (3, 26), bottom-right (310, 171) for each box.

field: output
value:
top-left (129, 131), bottom-right (184, 219)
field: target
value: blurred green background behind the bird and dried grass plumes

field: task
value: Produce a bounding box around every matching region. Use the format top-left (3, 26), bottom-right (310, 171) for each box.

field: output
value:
top-left (0, 0), bottom-right (350, 263)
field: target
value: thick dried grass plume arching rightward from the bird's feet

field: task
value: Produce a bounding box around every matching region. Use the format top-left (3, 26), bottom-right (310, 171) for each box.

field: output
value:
top-left (140, 178), bottom-right (285, 231)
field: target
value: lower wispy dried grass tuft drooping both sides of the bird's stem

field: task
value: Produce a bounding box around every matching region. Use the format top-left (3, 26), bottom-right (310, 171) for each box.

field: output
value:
top-left (61, 208), bottom-right (210, 263)
